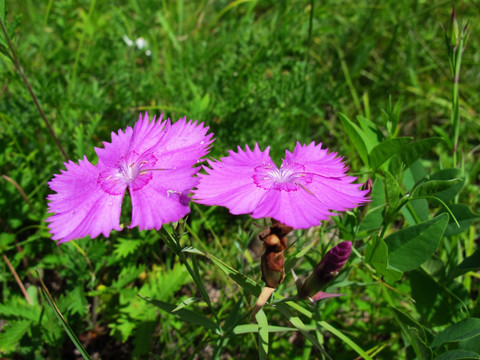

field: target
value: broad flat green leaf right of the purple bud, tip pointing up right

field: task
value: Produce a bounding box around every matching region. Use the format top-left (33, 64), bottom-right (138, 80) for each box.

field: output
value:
top-left (385, 214), bottom-right (448, 272)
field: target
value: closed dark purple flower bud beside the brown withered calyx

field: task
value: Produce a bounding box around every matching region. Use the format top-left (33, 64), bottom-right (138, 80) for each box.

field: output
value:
top-left (298, 241), bottom-right (352, 298)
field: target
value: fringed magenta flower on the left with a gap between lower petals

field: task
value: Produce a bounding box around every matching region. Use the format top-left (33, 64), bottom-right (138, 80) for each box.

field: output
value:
top-left (47, 113), bottom-right (213, 243)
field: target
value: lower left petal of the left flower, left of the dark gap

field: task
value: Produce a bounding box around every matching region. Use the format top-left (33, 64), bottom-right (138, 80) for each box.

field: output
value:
top-left (47, 157), bottom-right (123, 243)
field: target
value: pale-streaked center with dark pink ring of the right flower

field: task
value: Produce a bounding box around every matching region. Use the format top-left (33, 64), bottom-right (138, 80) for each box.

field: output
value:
top-left (253, 162), bottom-right (312, 191)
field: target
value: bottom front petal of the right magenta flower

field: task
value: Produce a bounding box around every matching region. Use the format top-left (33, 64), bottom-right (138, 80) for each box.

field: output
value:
top-left (252, 188), bottom-right (333, 229)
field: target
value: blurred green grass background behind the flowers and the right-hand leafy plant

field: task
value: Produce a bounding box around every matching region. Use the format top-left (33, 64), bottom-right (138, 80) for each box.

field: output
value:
top-left (0, 0), bottom-right (480, 359)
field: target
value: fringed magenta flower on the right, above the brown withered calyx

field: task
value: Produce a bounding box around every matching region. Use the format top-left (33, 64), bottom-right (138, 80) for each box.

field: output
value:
top-left (193, 142), bottom-right (368, 229)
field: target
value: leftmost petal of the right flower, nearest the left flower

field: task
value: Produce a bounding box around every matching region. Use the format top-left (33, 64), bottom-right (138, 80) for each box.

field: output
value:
top-left (194, 144), bottom-right (272, 214)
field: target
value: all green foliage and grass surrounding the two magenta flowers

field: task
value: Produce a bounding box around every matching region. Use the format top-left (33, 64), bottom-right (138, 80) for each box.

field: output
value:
top-left (0, 0), bottom-right (480, 359)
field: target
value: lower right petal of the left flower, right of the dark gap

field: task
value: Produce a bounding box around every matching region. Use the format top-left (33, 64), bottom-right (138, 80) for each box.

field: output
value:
top-left (129, 167), bottom-right (198, 230)
